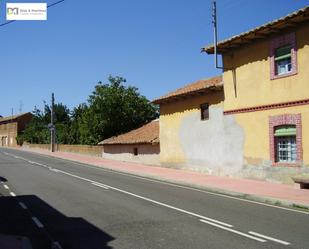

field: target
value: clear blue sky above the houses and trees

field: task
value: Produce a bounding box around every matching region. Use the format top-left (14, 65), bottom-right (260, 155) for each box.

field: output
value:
top-left (0, 0), bottom-right (309, 116)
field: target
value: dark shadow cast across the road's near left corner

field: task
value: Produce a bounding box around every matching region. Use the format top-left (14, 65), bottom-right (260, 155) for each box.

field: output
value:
top-left (0, 195), bottom-right (114, 249)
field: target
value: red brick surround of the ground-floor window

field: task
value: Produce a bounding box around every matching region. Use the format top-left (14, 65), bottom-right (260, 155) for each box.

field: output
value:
top-left (269, 113), bottom-right (303, 166)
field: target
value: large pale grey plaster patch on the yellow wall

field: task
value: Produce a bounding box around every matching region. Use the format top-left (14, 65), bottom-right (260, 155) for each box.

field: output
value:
top-left (179, 106), bottom-right (244, 176)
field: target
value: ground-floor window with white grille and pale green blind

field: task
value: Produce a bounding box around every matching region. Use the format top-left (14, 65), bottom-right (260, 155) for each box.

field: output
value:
top-left (274, 125), bottom-right (297, 163)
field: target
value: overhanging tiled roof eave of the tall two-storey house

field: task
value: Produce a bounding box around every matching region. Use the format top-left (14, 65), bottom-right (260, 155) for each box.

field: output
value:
top-left (202, 6), bottom-right (309, 54)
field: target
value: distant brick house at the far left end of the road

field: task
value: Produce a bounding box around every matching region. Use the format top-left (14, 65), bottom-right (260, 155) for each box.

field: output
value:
top-left (0, 112), bottom-right (32, 147)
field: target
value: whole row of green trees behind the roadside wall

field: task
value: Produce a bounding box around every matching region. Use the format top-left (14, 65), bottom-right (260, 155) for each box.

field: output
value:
top-left (18, 76), bottom-right (158, 145)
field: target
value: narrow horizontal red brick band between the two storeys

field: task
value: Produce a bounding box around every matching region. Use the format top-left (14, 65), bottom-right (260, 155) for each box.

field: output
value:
top-left (223, 99), bottom-right (309, 115)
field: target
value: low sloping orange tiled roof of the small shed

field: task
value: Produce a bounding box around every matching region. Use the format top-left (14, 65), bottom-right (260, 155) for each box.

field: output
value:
top-left (99, 119), bottom-right (159, 145)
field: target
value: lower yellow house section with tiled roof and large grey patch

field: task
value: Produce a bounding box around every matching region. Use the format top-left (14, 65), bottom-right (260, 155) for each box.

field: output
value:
top-left (153, 76), bottom-right (244, 175)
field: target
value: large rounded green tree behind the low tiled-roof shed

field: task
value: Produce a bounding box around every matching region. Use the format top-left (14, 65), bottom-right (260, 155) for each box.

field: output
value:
top-left (80, 76), bottom-right (158, 144)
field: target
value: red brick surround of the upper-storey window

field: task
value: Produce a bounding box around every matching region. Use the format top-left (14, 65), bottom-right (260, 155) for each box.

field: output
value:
top-left (269, 33), bottom-right (297, 80)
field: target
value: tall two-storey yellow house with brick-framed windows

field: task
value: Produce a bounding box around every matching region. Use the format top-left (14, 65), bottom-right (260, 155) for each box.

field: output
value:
top-left (202, 6), bottom-right (309, 182)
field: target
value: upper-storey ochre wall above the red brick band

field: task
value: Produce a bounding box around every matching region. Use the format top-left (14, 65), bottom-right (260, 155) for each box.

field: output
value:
top-left (223, 22), bottom-right (309, 111)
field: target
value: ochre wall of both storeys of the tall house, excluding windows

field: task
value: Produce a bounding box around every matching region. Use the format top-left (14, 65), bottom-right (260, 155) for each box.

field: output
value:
top-left (219, 22), bottom-right (309, 183)
